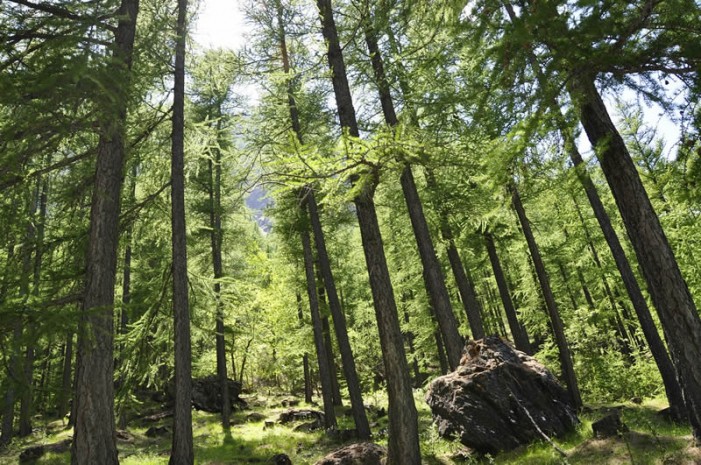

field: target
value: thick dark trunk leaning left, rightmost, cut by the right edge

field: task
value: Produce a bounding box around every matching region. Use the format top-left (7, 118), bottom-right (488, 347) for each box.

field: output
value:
top-left (571, 74), bottom-right (701, 441)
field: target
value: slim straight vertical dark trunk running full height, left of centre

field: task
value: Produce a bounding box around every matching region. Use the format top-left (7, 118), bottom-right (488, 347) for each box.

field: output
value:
top-left (168, 0), bottom-right (194, 465)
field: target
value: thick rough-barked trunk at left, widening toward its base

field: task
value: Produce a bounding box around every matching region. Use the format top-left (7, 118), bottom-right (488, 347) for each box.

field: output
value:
top-left (71, 0), bottom-right (139, 465)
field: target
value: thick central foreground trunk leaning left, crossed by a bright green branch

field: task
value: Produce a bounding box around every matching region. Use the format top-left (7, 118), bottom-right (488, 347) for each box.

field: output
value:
top-left (317, 0), bottom-right (421, 458)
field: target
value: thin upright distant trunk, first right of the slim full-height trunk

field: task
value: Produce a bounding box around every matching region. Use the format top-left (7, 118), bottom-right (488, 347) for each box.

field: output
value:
top-left (208, 140), bottom-right (231, 429)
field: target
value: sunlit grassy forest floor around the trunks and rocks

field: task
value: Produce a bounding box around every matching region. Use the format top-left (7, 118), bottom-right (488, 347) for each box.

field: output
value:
top-left (0, 391), bottom-right (701, 465)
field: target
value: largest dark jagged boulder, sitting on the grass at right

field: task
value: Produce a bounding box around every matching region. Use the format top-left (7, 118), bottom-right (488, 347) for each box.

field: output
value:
top-left (426, 336), bottom-right (579, 453)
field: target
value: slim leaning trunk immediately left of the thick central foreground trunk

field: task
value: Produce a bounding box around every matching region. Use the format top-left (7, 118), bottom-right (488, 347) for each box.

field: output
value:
top-left (306, 190), bottom-right (370, 439)
